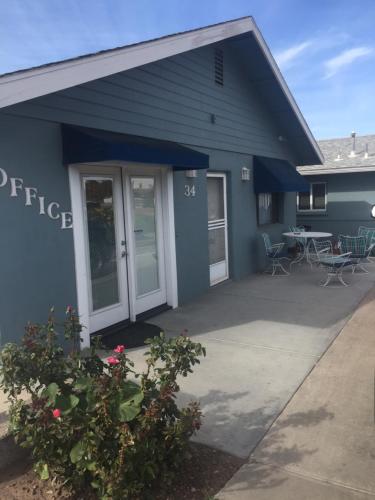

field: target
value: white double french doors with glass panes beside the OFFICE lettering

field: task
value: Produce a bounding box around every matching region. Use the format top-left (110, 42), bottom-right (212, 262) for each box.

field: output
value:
top-left (70, 165), bottom-right (170, 340)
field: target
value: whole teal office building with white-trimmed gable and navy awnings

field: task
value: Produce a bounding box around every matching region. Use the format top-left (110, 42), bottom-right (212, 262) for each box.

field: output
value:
top-left (0, 14), bottom-right (322, 345)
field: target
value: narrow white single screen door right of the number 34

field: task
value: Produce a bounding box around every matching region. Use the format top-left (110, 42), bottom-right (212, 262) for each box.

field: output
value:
top-left (207, 173), bottom-right (229, 286)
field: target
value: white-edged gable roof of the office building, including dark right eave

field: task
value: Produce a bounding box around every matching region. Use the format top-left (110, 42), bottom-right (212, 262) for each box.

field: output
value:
top-left (0, 17), bottom-right (323, 165)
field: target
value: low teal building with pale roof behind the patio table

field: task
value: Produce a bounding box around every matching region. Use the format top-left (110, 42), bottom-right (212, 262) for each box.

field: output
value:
top-left (297, 132), bottom-right (375, 236)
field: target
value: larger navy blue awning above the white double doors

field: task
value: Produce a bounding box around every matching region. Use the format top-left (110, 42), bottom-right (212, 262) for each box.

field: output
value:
top-left (61, 125), bottom-right (209, 170)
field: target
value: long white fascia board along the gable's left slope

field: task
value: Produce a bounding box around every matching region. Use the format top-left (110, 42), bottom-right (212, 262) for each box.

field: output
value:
top-left (0, 18), bottom-right (253, 108)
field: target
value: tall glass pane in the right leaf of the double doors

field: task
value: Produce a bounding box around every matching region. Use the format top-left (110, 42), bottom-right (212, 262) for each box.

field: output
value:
top-left (131, 177), bottom-right (159, 297)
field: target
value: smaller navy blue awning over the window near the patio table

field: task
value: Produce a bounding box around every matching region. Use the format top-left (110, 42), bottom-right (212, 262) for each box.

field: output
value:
top-left (254, 156), bottom-right (310, 193)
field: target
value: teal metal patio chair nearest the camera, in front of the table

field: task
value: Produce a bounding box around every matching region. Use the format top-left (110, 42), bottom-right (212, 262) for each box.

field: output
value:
top-left (312, 240), bottom-right (352, 287)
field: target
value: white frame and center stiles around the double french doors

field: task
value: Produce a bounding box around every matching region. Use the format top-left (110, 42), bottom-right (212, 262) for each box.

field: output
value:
top-left (68, 162), bottom-right (178, 347)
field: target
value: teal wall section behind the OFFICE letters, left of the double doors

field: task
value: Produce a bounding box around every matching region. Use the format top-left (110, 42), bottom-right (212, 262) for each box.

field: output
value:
top-left (0, 114), bottom-right (76, 344)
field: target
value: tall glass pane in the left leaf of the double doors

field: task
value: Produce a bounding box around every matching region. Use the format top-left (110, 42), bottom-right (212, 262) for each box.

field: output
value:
top-left (84, 178), bottom-right (119, 311)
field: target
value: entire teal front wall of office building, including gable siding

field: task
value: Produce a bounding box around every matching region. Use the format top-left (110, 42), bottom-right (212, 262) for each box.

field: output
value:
top-left (0, 40), bottom-right (295, 342)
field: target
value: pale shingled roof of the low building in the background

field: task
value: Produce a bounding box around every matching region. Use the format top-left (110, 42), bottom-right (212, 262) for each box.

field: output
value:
top-left (297, 135), bottom-right (375, 175)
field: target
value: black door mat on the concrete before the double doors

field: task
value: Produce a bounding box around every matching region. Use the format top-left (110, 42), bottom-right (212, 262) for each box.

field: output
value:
top-left (97, 321), bottom-right (162, 349)
